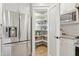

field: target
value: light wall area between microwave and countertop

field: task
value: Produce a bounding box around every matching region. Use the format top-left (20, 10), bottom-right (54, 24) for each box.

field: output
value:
top-left (61, 24), bottom-right (79, 35)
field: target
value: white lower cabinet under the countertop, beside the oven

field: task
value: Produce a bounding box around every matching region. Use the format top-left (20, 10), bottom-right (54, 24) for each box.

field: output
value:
top-left (60, 38), bottom-right (75, 56)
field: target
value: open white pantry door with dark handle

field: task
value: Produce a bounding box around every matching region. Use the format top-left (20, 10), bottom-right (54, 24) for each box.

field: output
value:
top-left (49, 3), bottom-right (60, 56)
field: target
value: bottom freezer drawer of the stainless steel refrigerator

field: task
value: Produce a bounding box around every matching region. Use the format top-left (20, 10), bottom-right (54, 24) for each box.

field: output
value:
top-left (2, 42), bottom-right (31, 56)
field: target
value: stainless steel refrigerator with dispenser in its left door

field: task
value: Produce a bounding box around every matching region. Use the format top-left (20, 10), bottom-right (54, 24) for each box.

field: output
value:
top-left (2, 4), bottom-right (32, 56)
